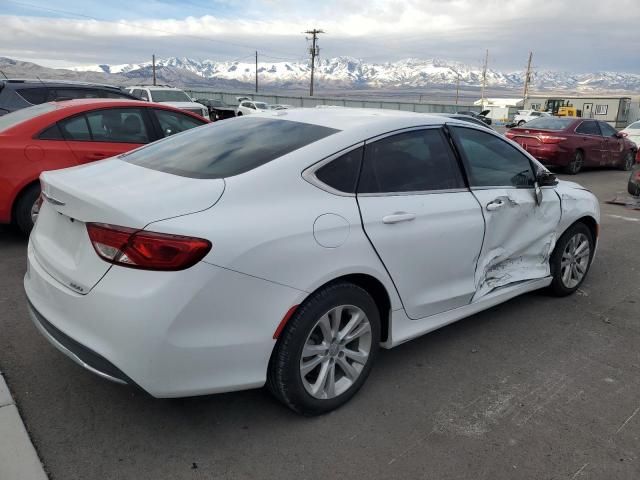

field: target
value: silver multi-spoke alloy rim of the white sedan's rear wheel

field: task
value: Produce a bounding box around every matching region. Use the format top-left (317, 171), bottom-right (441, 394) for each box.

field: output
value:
top-left (300, 305), bottom-right (372, 400)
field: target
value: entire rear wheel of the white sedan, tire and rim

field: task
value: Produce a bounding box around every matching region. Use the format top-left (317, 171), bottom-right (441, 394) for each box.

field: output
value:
top-left (268, 282), bottom-right (380, 415)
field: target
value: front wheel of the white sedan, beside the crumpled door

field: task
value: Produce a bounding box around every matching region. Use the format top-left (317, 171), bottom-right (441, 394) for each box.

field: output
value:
top-left (550, 223), bottom-right (594, 297)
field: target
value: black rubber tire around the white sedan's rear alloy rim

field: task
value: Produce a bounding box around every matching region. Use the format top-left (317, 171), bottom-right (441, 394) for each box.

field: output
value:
top-left (267, 282), bottom-right (380, 416)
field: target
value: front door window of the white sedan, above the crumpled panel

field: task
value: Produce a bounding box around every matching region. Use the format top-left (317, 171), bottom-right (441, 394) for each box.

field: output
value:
top-left (452, 127), bottom-right (535, 187)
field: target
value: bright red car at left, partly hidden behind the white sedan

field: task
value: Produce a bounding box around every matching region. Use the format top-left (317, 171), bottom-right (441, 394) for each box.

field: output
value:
top-left (0, 99), bottom-right (209, 233)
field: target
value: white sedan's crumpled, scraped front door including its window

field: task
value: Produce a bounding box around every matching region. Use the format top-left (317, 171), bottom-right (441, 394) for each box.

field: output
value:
top-left (451, 126), bottom-right (560, 300)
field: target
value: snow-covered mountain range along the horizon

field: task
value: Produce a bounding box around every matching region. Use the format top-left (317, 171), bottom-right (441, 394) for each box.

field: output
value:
top-left (72, 57), bottom-right (640, 91)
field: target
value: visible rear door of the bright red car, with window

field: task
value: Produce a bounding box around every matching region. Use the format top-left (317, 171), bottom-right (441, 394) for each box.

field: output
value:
top-left (59, 108), bottom-right (155, 163)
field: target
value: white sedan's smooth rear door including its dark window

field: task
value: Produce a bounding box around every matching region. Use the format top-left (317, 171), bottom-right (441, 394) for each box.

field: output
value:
top-left (357, 128), bottom-right (484, 319)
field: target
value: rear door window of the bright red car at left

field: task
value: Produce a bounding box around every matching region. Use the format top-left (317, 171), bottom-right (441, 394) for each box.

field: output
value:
top-left (87, 108), bottom-right (149, 143)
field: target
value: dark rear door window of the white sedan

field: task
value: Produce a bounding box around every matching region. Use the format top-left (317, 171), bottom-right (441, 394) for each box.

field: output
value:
top-left (358, 129), bottom-right (464, 193)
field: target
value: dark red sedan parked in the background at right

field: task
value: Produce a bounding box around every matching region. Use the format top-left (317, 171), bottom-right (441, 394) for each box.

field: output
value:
top-left (505, 117), bottom-right (637, 175)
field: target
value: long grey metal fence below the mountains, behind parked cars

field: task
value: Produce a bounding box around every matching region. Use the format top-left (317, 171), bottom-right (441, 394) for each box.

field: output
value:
top-left (186, 89), bottom-right (480, 113)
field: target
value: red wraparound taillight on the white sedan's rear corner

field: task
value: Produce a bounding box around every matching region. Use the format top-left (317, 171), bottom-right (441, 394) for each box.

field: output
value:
top-left (87, 223), bottom-right (211, 271)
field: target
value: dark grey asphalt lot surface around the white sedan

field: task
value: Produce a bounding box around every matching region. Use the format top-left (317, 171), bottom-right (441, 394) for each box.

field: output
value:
top-left (0, 170), bottom-right (640, 480)
